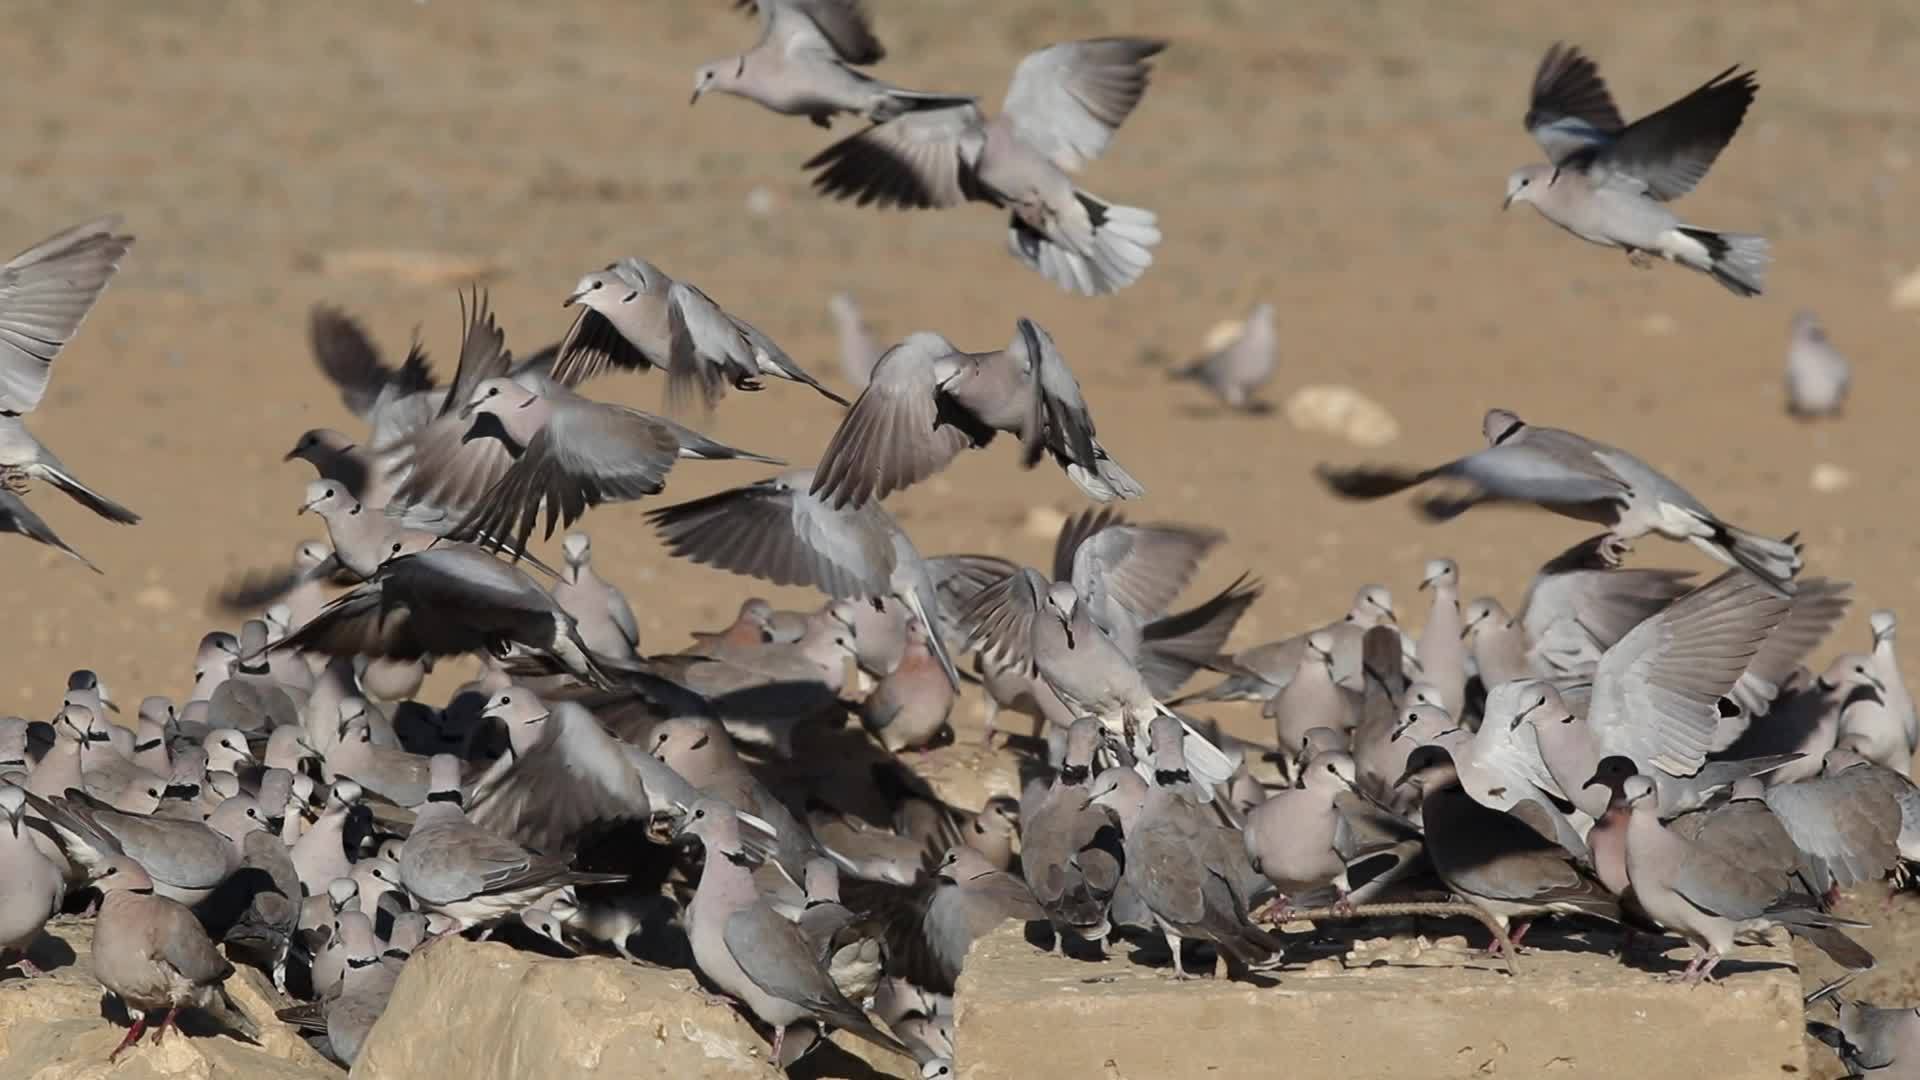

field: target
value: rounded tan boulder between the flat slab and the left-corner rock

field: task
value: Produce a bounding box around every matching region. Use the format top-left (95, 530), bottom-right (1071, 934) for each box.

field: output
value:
top-left (353, 936), bottom-right (920, 1080)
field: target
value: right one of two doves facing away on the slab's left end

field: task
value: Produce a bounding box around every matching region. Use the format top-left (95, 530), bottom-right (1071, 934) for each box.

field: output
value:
top-left (1125, 717), bottom-right (1286, 978)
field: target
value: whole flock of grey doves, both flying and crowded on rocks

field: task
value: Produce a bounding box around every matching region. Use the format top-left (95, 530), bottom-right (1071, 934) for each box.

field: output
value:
top-left (0, 0), bottom-right (1920, 1076)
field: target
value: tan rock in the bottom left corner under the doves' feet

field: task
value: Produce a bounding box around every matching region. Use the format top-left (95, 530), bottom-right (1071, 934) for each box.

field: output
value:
top-left (0, 919), bottom-right (340, 1080)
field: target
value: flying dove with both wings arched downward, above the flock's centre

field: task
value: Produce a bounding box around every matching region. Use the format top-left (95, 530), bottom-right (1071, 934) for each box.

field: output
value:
top-left (812, 319), bottom-right (1144, 509)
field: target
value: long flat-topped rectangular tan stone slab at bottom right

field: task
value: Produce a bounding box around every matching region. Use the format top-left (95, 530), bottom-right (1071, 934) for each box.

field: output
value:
top-left (954, 924), bottom-right (1807, 1080)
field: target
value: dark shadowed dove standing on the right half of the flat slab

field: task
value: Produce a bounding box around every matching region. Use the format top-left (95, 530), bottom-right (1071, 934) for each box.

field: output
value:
top-left (1402, 745), bottom-right (1620, 959)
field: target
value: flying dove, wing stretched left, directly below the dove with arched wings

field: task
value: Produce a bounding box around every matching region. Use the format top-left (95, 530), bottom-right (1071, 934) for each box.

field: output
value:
top-left (647, 461), bottom-right (960, 688)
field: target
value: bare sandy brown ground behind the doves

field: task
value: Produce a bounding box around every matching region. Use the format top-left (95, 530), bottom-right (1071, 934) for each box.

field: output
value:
top-left (0, 0), bottom-right (1920, 1068)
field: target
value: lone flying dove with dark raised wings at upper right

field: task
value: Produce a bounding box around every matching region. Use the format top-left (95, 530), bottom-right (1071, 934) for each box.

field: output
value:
top-left (1503, 44), bottom-right (1770, 296)
